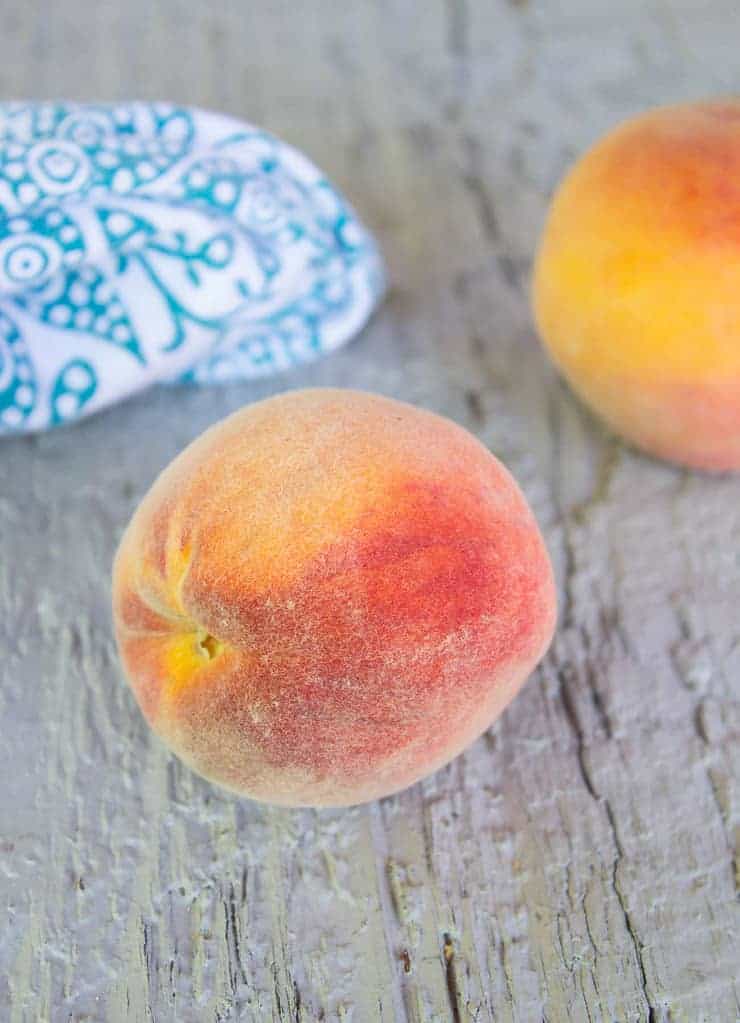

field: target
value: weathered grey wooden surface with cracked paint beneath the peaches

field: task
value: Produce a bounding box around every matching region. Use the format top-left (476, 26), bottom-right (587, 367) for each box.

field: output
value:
top-left (0, 0), bottom-right (740, 1023)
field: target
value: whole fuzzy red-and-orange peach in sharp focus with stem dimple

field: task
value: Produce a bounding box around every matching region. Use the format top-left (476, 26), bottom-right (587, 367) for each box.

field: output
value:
top-left (114, 390), bottom-right (556, 806)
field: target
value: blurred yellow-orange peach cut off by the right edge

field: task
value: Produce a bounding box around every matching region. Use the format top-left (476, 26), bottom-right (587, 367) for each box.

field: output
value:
top-left (533, 99), bottom-right (740, 471)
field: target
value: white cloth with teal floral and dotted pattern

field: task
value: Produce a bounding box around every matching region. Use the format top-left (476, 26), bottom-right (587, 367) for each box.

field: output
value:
top-left (0, 103), bottom-right (384, 435)
